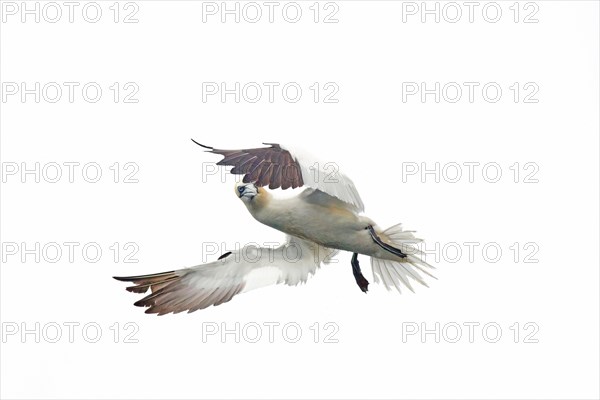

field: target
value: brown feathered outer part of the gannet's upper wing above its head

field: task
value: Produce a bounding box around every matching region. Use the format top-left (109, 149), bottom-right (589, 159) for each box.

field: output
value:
top-left (192, 139), bottom-right (304, 189)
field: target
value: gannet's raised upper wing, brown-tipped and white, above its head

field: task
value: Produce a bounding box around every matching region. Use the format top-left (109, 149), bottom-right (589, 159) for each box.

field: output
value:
top-left (192, 139), bottom-right (365, 212)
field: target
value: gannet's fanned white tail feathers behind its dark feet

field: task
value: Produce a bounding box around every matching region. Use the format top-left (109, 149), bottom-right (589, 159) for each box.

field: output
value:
top-left (371, 224), bottom-right (437, 293)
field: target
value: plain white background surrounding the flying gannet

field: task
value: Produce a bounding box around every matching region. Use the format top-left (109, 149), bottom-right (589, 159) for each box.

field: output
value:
top-left (0, 1), bottom-right (599, 398)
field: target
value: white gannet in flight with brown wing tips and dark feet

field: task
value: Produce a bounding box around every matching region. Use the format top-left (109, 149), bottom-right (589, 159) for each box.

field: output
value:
top-left (115, 139), bottom-right (435, 315)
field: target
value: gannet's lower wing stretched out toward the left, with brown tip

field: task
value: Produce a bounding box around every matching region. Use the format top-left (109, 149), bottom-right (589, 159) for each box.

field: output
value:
top-left (115, 236), bottom-right (334, 315)
